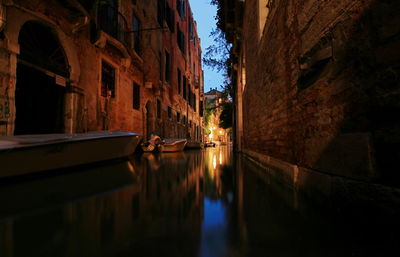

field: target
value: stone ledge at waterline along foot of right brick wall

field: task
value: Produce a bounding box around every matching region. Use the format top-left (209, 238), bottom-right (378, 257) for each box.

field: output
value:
top-left (242, 149), bottom-right (400, 213)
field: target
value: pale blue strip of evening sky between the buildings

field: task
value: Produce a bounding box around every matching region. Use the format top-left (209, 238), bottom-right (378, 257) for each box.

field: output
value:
top-left (189, 0), bottom-right (224, 92)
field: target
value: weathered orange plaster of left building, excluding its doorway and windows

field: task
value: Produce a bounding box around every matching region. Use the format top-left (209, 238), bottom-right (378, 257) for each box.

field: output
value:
top-left (0, 0), bottom-right (205, 140)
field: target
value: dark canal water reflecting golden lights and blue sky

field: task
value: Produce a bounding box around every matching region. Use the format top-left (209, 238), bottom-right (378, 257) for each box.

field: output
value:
top-left (0, 146), bottom-right (400, 257)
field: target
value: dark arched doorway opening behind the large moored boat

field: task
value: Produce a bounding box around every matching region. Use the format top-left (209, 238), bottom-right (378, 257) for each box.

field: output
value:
top-left (14, 22), bottom-right (69, 135)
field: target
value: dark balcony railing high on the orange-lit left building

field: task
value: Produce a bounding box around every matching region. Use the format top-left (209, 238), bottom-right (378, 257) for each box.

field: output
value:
top-left (97, 5), bottom-right (131, 47)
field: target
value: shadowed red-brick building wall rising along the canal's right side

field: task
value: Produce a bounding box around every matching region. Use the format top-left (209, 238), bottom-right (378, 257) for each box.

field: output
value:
top-left (218, 0), bottom-right (400, 194)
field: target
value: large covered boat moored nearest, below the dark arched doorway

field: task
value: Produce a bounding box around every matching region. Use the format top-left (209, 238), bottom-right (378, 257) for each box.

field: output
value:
top-left (0, 131), bottom-right (141, 178)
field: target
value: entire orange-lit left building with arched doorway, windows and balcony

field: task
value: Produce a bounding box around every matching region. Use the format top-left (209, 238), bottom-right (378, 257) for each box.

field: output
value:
top-left (0, 0), bottom-right (203, 140)
